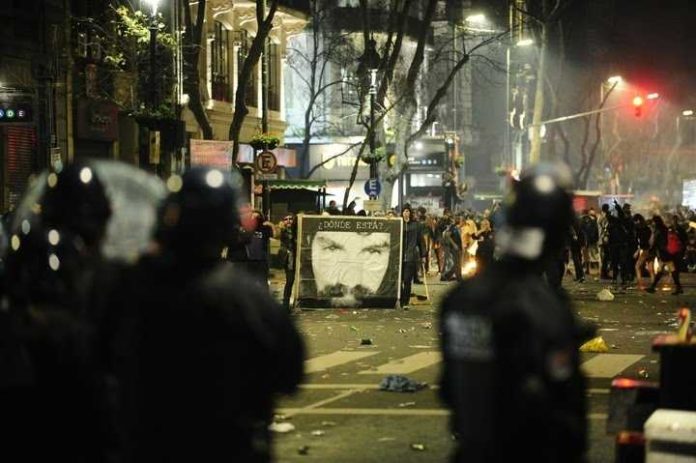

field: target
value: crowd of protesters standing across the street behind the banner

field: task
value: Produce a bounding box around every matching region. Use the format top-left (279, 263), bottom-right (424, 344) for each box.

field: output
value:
top-left (286, 201), bottom-right (696, 295)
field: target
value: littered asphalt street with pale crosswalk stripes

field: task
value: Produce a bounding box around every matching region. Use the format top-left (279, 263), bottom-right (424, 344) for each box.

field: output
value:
top-left (271, 272), bottom-right (696, 463)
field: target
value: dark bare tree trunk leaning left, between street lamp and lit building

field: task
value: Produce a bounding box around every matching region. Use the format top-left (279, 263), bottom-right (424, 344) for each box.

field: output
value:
top-left (182, 0), bottom-right (213, 140)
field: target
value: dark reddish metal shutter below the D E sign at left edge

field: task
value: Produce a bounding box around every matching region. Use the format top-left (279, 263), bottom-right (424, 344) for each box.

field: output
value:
top-left (3, 127), bottom-right (36, 209)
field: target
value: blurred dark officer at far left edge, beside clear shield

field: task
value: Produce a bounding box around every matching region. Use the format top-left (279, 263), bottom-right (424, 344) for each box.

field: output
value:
top-left (0, 164), bottom-right (117, 462)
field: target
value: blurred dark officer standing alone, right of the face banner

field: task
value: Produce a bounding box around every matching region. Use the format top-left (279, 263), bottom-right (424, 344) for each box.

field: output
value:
top-left (440, 165), bottom-right (586, 463)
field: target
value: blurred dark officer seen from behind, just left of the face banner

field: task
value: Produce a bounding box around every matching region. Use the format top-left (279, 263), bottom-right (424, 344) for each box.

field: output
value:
top-left (115, 168), bottom-right (303, 462)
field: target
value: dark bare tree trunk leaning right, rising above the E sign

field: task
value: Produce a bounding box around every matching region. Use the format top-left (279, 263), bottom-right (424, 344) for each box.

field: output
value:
top-left (229, 0), bottom-right (278, 165)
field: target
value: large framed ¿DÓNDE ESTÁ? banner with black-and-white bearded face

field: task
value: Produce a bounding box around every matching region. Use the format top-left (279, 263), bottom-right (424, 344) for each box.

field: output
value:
top-left (299, 216), bottom-right (401, 307)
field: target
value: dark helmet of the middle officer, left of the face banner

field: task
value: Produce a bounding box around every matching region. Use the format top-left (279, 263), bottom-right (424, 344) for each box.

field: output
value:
top-left (157, 167), bottom-right (240, 258)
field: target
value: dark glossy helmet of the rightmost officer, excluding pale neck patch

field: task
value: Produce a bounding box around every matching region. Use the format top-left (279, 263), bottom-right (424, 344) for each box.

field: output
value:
top-left (505, 163), bottom-right (574, 254)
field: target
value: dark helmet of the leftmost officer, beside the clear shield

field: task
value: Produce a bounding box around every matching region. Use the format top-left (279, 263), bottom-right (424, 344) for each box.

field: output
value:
top-left (40, 163), bottom-right (111, 250)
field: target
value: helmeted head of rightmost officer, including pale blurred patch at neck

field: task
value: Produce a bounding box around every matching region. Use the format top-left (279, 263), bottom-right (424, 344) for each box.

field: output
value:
top-left (497, 164), bottom-right (574, 260)
